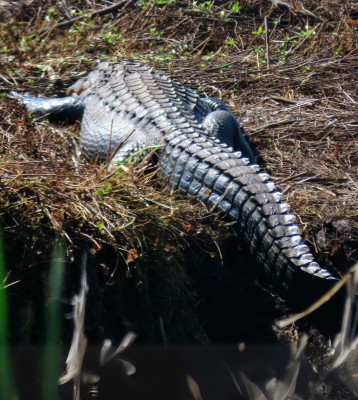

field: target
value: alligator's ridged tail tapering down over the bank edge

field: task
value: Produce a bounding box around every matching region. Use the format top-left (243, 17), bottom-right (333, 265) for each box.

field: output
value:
top-left (160, 132), bottom-right (336, 287)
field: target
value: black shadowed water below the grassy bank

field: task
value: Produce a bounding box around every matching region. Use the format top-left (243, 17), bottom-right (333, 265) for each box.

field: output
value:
top-left (5, 230), bottom-right (357, 400)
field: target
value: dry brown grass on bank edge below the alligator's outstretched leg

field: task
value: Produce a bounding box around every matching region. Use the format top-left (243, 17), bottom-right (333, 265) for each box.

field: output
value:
top-left (0, 97), bottom-right (227, 261)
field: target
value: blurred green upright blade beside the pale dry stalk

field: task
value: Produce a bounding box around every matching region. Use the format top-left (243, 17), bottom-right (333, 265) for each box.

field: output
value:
top-left (42, 242), bottom-right (65, 400)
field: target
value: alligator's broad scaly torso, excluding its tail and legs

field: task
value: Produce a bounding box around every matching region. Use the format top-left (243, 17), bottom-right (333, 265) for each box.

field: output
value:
top-left (68, 62), bottom-right (214, 163)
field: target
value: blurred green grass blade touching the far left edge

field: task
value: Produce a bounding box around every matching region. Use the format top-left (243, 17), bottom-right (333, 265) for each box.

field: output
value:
top-left (0, 231), bottom-right (18, 399)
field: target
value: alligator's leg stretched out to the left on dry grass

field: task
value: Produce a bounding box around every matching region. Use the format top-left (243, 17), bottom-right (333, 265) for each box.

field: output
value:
top-left (9, 92), bottom-right (84, 118)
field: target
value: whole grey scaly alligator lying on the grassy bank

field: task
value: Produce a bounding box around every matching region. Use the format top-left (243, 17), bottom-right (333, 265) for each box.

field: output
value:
top-left (12, 60), bottom-right (337, 293)
